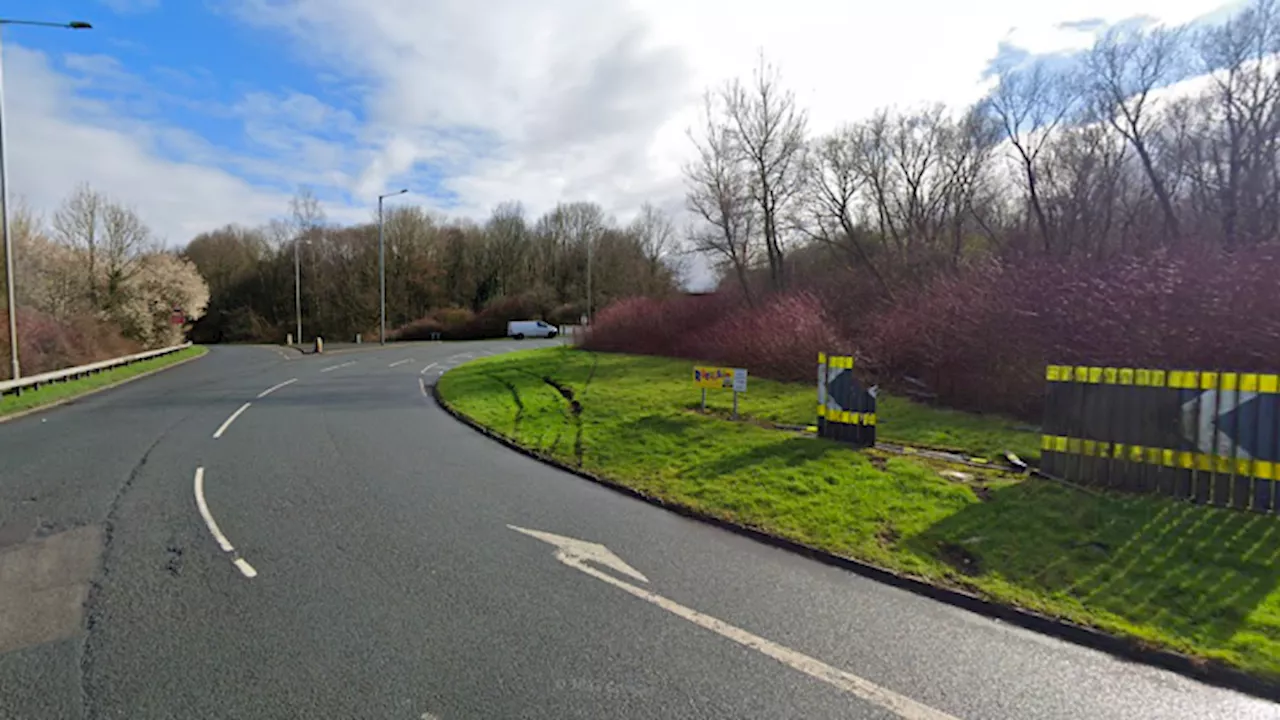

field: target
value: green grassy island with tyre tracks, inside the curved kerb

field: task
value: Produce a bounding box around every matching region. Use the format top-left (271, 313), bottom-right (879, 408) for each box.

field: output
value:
top-left (439, 348), bottom-right (1280, 680)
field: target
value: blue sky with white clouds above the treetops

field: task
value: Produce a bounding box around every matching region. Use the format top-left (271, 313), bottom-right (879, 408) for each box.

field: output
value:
top-left (0, 0), bottom-right (1240, 246)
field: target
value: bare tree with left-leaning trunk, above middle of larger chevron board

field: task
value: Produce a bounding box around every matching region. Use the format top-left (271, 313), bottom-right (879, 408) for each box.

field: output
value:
top-left (1085, 27), bottom-right (1183, 240)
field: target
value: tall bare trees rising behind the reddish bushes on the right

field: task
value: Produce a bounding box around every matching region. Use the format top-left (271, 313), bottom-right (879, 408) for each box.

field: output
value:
top-left (685, 0), bottom-right (1280, 297)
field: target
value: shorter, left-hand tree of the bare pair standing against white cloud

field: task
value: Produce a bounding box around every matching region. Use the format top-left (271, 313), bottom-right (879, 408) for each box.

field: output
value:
top-left (684, 95), bottom-right (755, 302)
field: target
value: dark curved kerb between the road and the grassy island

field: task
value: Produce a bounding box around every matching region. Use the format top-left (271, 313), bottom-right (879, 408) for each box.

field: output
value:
top-left (431, 383), bottom-right (1280, 701)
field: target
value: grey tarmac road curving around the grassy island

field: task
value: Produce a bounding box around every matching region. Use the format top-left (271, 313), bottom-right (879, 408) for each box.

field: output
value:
top-left (0, 341), bottom-right (1280, 720)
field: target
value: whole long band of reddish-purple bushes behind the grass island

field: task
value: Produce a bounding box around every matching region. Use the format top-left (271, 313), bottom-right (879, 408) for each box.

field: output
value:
top-left (585, 247), bottom-right (1280, 418)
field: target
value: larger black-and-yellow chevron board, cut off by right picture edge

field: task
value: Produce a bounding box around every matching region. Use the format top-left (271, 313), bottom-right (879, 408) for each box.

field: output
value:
top-left (1041, 365), bottom-right (1280, 512)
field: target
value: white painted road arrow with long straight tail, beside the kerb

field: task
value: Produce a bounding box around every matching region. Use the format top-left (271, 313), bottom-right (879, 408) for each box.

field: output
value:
top-left (507, 525), bottom-right (956, 720)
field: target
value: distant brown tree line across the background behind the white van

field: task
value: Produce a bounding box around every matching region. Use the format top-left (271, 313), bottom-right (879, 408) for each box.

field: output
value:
top-left (183, 190), bottom-right (680, 342)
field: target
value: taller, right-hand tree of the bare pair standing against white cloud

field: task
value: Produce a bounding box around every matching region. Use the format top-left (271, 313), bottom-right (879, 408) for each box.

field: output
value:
top-left (722, 54), bottom-right (806, 288)
